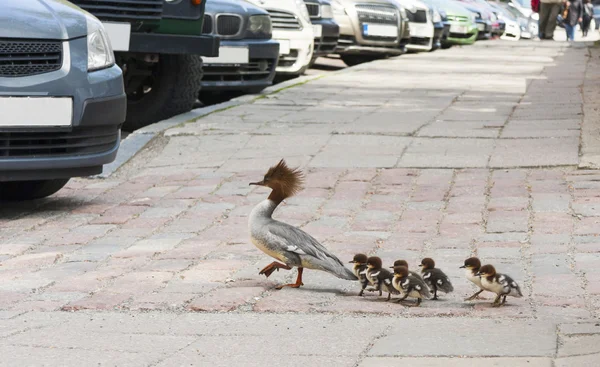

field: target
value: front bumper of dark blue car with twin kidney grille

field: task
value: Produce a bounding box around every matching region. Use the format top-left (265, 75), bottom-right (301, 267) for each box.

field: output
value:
top-left (201, 40), bottom-right (279, 91)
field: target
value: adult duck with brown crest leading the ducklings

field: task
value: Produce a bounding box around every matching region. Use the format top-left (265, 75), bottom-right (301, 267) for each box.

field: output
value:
top-left (248, 159), bottom-right (358, 289)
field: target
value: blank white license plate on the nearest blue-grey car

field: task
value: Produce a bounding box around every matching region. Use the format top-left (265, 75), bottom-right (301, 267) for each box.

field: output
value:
top-left (0, 97), bottom-right (73, 127)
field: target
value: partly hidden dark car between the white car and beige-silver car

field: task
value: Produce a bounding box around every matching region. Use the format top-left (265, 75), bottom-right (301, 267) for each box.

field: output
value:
top-left (304, 0), bottom-right (340, 64)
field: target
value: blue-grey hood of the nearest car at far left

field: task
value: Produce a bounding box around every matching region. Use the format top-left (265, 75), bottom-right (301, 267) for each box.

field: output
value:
top-left (0, 0), bottom-right (87, 40)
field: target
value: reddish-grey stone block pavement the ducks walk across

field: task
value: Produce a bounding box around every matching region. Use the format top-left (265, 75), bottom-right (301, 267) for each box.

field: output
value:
top-left (0, 41), bottom-right (600, 366)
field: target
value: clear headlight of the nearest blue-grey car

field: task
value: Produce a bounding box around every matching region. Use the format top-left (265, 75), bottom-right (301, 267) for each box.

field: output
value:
top-left (86, 14), bottom-right (115, 71)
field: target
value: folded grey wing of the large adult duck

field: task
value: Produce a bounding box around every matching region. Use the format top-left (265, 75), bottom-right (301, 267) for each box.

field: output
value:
top-left (267, 221), bottom-right (358, 280)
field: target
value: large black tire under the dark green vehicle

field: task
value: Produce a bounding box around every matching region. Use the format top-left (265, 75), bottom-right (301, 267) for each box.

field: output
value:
top-left (123, 55), bottom-right (202, 131)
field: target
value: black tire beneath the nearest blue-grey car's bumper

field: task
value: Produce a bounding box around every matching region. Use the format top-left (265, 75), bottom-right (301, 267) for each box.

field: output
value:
top-left (0, 178), bottom-right (69, 201)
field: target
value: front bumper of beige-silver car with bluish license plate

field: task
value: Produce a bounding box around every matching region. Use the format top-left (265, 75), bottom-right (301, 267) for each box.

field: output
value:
top-left (335, 11), bottom-right (404, 55)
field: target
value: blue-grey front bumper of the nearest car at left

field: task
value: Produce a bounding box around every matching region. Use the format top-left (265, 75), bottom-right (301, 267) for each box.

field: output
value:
top-left (0, 38), bottom-right (127, 181)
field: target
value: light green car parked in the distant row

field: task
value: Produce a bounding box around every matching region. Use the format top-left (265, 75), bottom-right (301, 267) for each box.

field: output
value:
top-left (422, 0), bottom-right (478, 48)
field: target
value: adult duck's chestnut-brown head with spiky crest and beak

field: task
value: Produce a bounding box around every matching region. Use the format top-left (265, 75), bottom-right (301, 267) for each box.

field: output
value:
top-left (250, 159), bottom-right (304, 204)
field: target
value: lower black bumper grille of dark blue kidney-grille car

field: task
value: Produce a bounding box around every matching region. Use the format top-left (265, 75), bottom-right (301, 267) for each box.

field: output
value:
top-left (202, 59), bottom-right (275, 82)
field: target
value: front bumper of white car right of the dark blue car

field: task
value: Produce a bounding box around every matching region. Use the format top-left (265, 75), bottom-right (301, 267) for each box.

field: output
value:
top-left (273, 27), bottom-right (314, 75)
